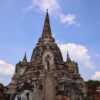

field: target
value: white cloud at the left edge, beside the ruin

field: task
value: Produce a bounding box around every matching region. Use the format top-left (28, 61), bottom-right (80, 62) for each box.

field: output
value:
top-left (0, 60), bottom-right (15, 75)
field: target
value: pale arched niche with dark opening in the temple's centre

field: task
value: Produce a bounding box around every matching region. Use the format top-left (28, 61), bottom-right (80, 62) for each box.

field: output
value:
top-left (43, 51), bottom-right (54, 70)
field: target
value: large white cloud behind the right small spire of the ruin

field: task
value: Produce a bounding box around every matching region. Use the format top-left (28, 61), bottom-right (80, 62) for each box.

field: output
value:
top-left (59, 43), bottom-right (94, 68)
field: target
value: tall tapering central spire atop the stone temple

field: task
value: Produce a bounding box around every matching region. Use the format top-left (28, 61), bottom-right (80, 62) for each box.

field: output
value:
top-left (42, 9), bottom-right (52, 37)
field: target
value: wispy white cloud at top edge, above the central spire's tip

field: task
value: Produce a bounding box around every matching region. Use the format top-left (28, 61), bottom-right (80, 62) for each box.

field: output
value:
top-left (27, 0), bottom-right (60, 13)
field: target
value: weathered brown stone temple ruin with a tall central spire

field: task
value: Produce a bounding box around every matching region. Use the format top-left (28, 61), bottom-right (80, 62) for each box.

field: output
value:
top-left (0, 11), bottom-right (86, 100)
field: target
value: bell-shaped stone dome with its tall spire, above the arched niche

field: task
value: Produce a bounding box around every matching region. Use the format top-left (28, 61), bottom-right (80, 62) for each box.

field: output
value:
top-left (31, 11), bottom-right (63, 62)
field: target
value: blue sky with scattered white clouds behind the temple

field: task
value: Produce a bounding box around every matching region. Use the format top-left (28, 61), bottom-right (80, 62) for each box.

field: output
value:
top-left (0, 0), bottom-right (100, 85)
